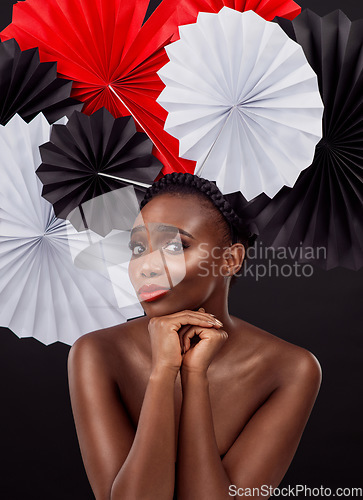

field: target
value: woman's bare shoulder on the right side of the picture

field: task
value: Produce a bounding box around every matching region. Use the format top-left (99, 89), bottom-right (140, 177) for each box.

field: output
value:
top-left (233, 320), bottom-right (322, 391)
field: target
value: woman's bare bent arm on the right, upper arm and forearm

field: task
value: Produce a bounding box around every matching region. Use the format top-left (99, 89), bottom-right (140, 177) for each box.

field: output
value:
top-left (177, 316), bottom-right (321, 500)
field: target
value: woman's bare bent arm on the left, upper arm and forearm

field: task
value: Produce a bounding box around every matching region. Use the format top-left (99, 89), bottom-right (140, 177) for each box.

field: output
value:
top-left (68, 338), bottom-right (177, 500)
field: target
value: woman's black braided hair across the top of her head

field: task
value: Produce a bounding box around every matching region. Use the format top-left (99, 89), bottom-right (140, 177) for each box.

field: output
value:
top-left (140, 172), bottom-right (257, 279)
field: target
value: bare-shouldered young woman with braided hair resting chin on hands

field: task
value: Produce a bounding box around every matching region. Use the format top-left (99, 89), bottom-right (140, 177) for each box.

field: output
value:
top-left (68, 173), bottom-right (321, 500)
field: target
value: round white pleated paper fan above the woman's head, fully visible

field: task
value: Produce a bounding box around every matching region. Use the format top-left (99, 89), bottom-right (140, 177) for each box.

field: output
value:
top-left (158, 7), bottom-right (323, 200)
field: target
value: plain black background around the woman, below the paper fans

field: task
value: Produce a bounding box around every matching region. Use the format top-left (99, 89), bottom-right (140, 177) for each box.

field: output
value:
top-left (0, 0), bottom-right (363, 500)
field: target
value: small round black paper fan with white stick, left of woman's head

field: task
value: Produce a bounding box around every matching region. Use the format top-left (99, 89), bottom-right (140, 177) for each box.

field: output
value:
top-left (37, 108), bottom-right (162, 232)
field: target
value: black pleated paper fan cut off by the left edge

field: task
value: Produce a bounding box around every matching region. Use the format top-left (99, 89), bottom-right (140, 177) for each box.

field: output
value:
top-left (0, 39), bottom-right (83, 125)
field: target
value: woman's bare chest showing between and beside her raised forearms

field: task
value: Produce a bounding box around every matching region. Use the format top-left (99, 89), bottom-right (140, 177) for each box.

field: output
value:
top-left (112, 340), bottom-right (271, 455)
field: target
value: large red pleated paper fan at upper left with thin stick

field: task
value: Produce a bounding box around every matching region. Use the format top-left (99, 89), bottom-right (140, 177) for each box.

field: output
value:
top-left (1, 0), bottom-right (195, 176)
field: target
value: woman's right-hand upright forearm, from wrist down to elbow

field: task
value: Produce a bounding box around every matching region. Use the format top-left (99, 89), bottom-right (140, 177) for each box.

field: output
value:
top-left (177, 369), bottom-right (230, 500)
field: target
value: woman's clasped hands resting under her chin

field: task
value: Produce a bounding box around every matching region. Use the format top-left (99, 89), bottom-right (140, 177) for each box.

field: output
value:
top-left (148, 308), bottom-right (228, 372)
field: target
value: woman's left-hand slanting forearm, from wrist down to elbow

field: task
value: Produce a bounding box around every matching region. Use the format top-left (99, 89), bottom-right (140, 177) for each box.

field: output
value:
top-left (111, 367), bottom-right (177, 500)
